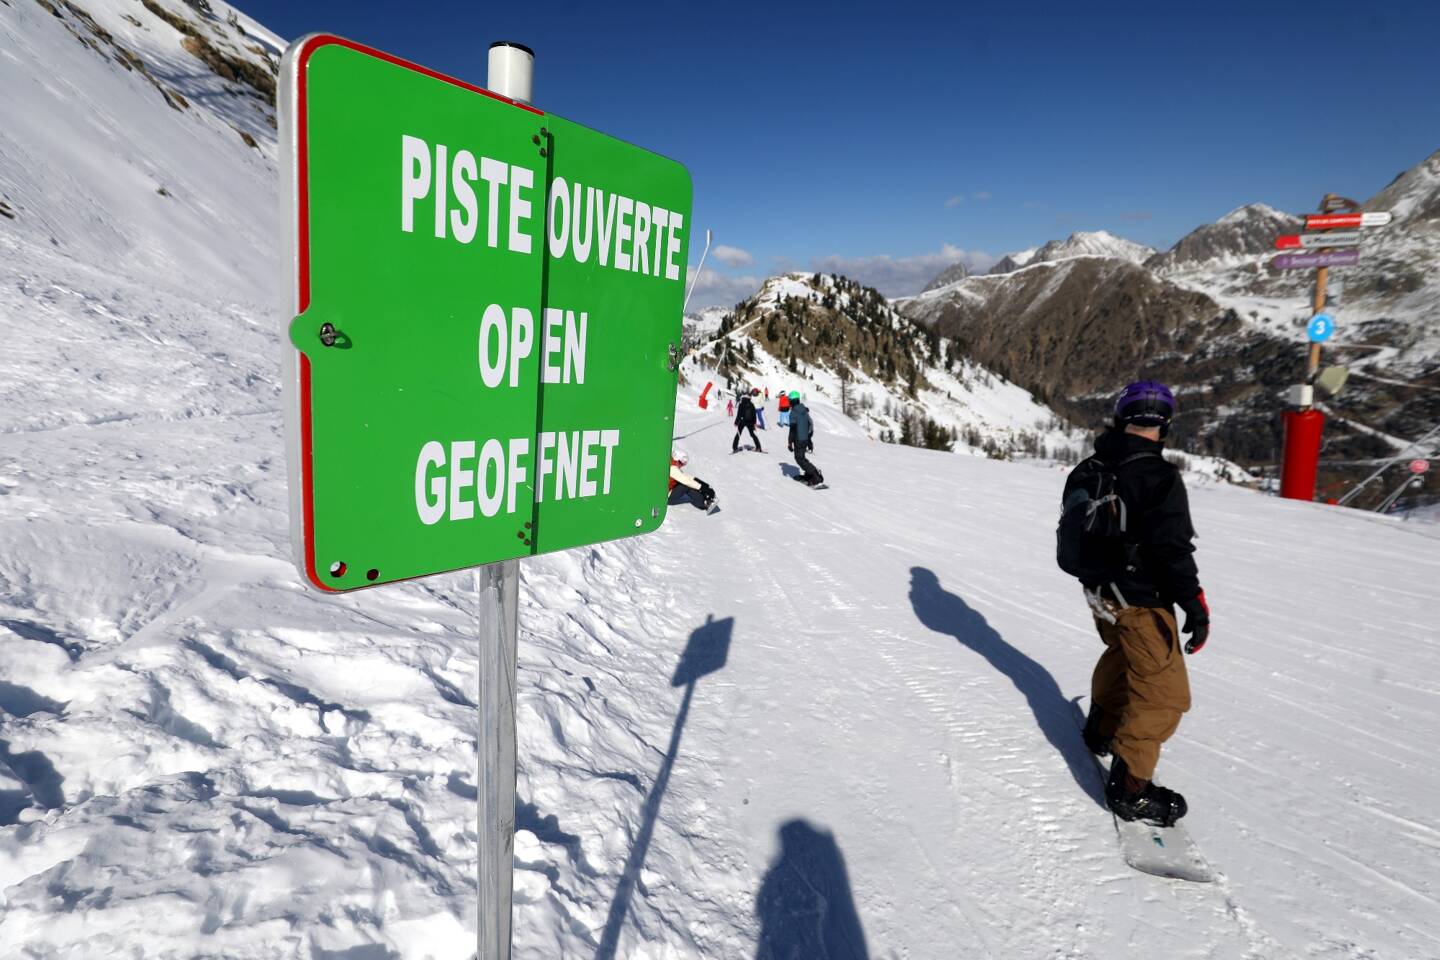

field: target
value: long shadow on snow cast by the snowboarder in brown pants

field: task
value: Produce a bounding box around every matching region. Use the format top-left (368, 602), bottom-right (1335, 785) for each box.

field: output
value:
top-left (910, 567), bottom-right (1104, 807)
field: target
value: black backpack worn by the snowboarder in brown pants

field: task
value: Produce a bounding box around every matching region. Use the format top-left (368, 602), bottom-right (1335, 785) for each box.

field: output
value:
top-left (1056, 450), bottom-right (1159, 583)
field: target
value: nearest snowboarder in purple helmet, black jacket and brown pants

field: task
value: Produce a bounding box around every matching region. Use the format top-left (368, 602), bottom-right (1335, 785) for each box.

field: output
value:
top-left (1057, 380), bottom-right (1210, 826)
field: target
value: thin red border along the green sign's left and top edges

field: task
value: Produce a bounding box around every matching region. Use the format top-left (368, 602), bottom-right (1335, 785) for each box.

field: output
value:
top-left (295, 33), bottom-right (544, 593)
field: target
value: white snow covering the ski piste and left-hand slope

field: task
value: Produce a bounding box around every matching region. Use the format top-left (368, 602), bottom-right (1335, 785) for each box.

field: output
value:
top-left (0, 0), bottom-right (1440, 960)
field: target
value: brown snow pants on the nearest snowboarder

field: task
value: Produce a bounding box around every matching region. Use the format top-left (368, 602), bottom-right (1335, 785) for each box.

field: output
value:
top-left (1090, 602), bottom-right (1189, 780)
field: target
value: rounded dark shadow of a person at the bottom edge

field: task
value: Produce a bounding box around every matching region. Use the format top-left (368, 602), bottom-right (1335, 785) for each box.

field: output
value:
top-left (755, 820), bottom-right (870, 960)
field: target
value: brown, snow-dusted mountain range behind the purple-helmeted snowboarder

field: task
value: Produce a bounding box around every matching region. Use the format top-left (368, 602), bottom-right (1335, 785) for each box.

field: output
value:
top-left (900, 147), bottom-right (1440, 498)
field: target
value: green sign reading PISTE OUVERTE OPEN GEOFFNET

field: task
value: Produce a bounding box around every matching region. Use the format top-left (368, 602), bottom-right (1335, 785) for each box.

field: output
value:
top-left (281, 35), bottom-right (691, 590)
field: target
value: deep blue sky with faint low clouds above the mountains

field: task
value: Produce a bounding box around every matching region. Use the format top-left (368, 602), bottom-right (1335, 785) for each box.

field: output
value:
top-left (240, 0), bottom-right (1440, 308)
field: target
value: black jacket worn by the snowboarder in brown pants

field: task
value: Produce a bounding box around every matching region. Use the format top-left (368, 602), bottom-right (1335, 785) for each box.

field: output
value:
top-left (1066, 429), bottom-right (1200, 606)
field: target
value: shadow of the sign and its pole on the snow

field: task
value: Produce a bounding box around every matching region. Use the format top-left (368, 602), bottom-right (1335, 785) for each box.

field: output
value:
top-left (595, 615), bottom-right (734, 960)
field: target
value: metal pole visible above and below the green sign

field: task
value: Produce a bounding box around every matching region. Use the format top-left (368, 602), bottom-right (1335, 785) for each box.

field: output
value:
top-left (475, 42), bottom-right (534, 960)
